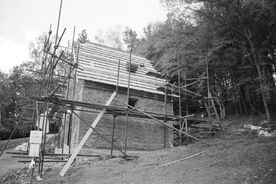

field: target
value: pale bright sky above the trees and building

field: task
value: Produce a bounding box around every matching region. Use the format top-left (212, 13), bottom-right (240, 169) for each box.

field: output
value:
top-left (0, 0), bottom-right (166, 73)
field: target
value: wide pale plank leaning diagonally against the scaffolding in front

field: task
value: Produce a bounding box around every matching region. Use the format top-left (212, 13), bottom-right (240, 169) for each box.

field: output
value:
top-left (59, 92), bottom-right (117, 177)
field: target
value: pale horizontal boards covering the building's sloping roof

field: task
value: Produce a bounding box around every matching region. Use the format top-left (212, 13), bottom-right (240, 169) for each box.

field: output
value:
top-left (75, 43), bottom-right (165, 94)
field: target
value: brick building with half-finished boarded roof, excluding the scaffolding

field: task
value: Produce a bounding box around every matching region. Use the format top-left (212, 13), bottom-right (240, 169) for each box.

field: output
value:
top-left (68, 43), bottom-right (173, 150)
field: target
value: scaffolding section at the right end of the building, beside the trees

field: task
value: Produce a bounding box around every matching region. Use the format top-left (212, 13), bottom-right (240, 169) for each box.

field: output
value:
top-left (157, 54), bottom-right (222, 145)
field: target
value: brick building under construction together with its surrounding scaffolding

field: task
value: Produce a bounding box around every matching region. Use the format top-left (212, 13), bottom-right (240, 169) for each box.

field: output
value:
top-left (2, 1), bottom-right (220, 177)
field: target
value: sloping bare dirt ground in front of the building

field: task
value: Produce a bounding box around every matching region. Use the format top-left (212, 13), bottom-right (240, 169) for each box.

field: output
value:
top-left (0, 117), bottom-right (276, 184)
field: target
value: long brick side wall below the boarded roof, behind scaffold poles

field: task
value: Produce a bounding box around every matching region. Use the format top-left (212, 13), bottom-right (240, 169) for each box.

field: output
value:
top-left (79, 82), bottom-right (173, 150)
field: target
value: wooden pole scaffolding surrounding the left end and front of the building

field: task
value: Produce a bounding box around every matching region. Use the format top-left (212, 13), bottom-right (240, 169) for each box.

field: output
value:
top-left (2, 0), bottom-right (222, 178)
